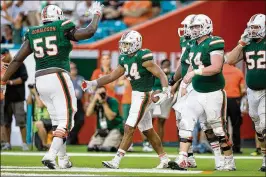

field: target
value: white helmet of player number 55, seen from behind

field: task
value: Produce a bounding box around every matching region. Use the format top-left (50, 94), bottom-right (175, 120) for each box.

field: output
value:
top-left (41, 5), bottom-right (65, 23)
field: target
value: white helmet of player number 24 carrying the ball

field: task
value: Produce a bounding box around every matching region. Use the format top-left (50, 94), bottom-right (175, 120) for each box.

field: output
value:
top-left (119, 30), bottom-right (142, 55)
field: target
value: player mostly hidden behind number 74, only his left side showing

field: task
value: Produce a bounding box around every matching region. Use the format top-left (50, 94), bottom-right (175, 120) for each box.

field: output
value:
top-left (169, 14), bottom-right (222, 169)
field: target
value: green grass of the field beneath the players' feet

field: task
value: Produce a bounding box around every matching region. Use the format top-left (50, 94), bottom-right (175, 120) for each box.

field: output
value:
top-left (1, 146), bottom-right (265, 176)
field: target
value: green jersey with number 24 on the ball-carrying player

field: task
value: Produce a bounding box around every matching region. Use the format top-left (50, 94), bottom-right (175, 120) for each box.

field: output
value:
top-left (119, 49), bottom-right (154, 92)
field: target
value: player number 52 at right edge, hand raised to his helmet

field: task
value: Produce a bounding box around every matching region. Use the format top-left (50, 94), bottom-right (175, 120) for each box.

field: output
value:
top-left (226, 14), bottom-right (266, 172)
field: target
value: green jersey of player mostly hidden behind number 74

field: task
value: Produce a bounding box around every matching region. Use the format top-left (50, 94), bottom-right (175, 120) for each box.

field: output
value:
top-left (180, 37), bottom-right (191, 78)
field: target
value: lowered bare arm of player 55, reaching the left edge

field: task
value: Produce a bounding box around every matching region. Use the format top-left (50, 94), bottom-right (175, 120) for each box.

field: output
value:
top-left (1, 40), bottom-right (32, 84)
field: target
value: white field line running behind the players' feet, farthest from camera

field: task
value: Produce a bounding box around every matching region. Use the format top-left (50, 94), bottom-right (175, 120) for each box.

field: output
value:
top-left (1, 152), bottom-right (262, 160)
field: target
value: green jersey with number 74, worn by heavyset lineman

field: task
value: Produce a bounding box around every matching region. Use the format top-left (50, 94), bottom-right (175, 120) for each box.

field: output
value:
top-left (189, 36), bottom-right (225, 93)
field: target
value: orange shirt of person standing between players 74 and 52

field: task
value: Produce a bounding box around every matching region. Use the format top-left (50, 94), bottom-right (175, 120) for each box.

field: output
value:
top-left (223, 64), bottom-right (245, 98)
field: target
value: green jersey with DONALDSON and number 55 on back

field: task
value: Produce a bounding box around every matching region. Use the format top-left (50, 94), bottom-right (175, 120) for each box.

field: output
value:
top-left (25, 20), bottom-right (75, 72)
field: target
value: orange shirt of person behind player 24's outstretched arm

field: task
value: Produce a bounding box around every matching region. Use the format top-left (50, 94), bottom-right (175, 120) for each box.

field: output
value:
top-left (91, 68), bottom-right (115, 98)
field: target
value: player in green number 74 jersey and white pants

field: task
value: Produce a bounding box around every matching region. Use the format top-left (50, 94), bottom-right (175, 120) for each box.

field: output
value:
top-left (171, 14), bottom-right (236, 170)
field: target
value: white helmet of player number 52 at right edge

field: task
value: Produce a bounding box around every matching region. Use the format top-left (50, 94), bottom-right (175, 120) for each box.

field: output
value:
top-left (247, 14), bottom-right (265, 38)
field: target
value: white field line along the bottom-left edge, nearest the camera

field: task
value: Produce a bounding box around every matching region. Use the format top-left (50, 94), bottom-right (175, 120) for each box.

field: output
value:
top-left (1, 172), bottom-right (108, 176)
